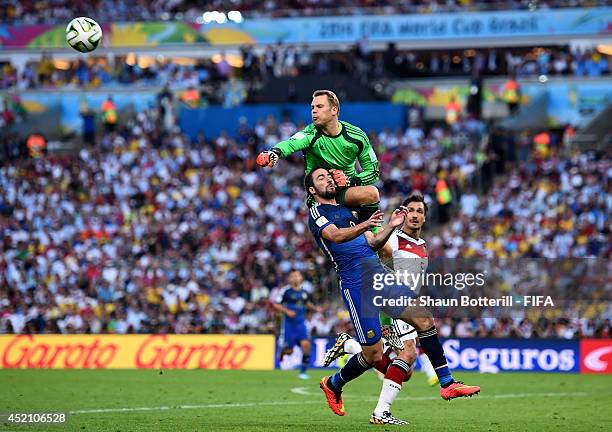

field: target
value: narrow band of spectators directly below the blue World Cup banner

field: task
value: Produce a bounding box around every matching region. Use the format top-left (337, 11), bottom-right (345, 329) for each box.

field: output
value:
top-left (0, 45), bottom-right (610, 93)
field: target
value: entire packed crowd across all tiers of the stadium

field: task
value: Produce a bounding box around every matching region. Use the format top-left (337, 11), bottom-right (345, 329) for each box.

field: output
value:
top-left (0, 0), bottom-right (612, 339)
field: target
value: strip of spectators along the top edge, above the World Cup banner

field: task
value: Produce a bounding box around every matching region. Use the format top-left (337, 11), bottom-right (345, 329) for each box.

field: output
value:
top-left (0, 0), bottom-right (606, 24)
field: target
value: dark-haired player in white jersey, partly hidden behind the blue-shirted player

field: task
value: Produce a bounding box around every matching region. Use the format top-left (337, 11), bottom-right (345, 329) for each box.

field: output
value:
top-left (324, 194), bottom-right (437, 424)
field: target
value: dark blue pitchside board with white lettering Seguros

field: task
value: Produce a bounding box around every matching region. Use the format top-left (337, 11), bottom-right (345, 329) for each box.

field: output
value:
top-left (276, 338), bottom-right (584, 373)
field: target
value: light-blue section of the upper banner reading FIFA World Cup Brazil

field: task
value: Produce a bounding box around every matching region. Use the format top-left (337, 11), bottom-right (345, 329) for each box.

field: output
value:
top-left (222, 8), bottom-right (612, 43)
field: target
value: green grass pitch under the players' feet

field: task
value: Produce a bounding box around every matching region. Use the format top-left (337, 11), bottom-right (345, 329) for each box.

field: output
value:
top-left (0, 370), bottom-right (612, 432)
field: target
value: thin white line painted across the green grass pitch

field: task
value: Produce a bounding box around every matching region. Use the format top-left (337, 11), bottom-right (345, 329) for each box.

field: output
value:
top-left (69, 387), bottom-right (589, 414)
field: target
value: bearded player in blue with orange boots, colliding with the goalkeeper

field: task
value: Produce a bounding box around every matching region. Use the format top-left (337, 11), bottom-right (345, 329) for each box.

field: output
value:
top-left (304, 168), bottom-right (480, 422)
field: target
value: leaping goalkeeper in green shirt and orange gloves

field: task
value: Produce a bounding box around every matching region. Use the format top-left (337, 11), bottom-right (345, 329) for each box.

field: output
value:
top-left (257, 90), bottom-right (380, 220)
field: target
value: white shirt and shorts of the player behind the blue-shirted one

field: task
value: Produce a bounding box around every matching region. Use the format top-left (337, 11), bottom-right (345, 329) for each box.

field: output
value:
top-left (389, 230), bottom-right (428, 341)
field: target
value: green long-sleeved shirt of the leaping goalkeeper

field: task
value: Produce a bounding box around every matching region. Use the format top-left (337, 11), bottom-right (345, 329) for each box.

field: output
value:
top-left (274, 121), bottom-right (380, 186)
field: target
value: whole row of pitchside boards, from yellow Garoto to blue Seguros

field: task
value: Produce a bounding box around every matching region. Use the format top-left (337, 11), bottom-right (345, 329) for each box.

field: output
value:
top-left (0, 335), bottom-right (612, 374)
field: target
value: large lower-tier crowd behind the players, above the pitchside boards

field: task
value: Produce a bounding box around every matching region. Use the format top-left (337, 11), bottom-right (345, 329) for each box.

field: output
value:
top-left (0, 94), bottom-right (612, 337)
